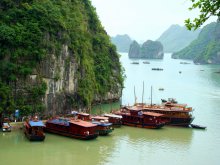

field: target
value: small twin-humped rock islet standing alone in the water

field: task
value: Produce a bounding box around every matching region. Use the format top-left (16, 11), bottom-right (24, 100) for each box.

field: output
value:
top-left (128, 40), bottom-right (164, 59)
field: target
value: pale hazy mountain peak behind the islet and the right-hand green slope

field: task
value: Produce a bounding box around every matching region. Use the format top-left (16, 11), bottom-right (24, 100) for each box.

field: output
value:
top-left (157, 25), bottom-right (200, 52)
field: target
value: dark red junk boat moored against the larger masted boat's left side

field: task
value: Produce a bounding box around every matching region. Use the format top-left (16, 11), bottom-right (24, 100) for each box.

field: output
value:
top-left (114, 106), bottom-right (166, 128)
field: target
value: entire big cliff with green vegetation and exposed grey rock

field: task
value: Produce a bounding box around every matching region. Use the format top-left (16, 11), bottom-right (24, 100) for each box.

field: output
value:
top-left (0, 0), bottom-right (123, 114)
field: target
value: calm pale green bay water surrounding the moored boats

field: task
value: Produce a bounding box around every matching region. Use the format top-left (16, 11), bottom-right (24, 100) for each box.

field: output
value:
top-left (0, 54), bottom-right (220, 165)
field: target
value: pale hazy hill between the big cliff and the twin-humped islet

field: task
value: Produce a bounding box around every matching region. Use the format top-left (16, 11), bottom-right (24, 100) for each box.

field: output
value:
top-left (111, 34), bottom-right (132, 52)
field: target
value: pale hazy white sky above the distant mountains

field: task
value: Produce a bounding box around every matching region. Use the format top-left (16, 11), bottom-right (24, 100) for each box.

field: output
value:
top-left (91, 0), bottom-right (217, 42)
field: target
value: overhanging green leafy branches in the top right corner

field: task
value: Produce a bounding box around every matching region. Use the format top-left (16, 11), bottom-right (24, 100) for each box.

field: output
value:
top-left (185, 0), bottom-right (220, 30)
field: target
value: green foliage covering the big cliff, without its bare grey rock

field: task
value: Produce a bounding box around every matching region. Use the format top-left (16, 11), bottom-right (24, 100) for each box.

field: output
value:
top-left (0, 0), bottom-right (123, 112)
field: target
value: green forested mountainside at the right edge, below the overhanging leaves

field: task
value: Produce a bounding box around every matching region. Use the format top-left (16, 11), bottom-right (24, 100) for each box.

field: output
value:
top-left (172, 22), bottom-right (220, 64)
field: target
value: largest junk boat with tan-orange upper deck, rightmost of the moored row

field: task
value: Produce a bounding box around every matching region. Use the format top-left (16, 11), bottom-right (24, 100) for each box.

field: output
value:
top-left (135, 99), bottom-right (194, 127)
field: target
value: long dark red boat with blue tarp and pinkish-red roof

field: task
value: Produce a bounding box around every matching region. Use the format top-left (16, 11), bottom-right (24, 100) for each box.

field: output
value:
top-left (45, 118), bottom-right (98, 140)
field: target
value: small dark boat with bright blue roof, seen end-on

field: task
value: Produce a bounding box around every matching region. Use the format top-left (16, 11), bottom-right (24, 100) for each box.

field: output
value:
top-left (24, 117), bottom-right (45, 141)
